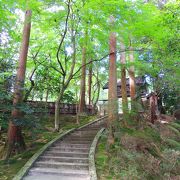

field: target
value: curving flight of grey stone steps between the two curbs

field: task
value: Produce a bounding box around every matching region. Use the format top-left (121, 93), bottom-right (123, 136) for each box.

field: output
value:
top-left (23, 120), bottom-right (104, 180)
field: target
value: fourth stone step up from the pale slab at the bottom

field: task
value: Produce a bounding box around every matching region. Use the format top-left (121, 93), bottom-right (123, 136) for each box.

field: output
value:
top-left (47, 146), bottom-right (89, 152)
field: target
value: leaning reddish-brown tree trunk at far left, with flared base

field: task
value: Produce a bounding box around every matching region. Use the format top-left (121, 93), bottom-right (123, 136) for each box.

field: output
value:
top-left (5, 10), bottom-right (31, 159)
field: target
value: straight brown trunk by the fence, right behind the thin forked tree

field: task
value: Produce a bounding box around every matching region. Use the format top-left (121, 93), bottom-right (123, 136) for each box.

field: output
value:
top-left (79, 47), bottom-right (86, 113)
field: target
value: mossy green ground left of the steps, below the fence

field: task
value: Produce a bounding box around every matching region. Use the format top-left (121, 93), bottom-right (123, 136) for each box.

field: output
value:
top-left (0, 115), bottom-right (96, 180)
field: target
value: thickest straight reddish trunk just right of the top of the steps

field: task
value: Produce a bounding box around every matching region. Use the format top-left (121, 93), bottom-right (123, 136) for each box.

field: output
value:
top-left (107, 17), bottom-right (118, 146)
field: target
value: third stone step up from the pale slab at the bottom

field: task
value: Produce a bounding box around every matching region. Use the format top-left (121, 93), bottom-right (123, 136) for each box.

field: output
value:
top-left (44, 151), bottom-right (88, 157)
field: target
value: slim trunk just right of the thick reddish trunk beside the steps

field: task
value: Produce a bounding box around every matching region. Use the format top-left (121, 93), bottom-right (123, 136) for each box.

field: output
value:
top-left (120, 42), bottom-right (128, 115)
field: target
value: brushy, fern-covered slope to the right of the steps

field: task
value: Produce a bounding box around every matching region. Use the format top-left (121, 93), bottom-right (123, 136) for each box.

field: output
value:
top-left (95, 116), bottom-right (180, 180)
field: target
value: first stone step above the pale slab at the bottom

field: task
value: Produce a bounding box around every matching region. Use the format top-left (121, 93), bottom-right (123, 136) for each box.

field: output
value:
top-left (34, 161), bottom-right (89, 170)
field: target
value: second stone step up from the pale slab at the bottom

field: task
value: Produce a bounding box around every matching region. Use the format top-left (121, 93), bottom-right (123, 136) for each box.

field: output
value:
top-left (39, 156), bottom-right (89, 163)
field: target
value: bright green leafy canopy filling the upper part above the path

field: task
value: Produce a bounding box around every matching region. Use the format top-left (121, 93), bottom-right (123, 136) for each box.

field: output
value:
top-left (0, 0), bottom-right (180, 113)
